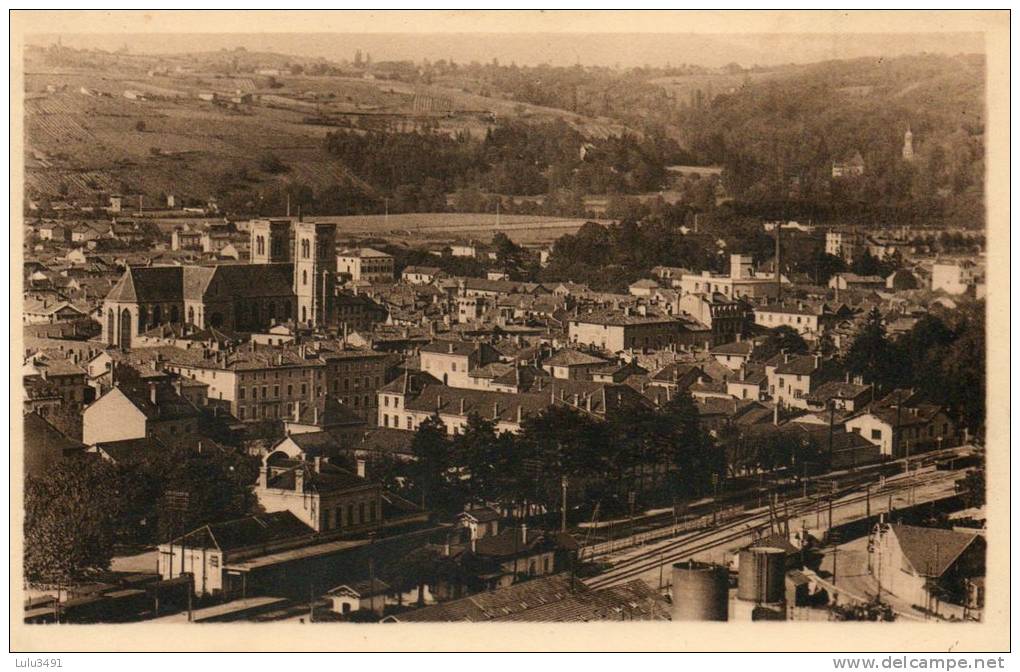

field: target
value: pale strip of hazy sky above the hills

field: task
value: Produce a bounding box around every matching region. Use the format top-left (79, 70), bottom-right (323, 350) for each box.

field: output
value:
top-left (27, 32), bottom-right (984, 67)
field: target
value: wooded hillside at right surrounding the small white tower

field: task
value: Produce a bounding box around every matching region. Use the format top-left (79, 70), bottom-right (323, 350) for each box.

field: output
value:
top-left (682, 55), bottom-right (984, 225)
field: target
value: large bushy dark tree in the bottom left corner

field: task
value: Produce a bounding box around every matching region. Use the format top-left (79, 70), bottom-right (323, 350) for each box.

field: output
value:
top-left (24, 455), bottom-right (120, 583)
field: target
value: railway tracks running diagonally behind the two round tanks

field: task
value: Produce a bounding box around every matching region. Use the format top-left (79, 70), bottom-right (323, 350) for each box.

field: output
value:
top-left (585, 472), bottom-right (959, 588)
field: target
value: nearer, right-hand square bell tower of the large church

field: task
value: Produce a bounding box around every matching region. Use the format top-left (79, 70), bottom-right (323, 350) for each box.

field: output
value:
top-left (294, 221), bottom-right (337, 327)
